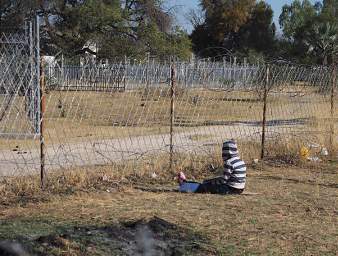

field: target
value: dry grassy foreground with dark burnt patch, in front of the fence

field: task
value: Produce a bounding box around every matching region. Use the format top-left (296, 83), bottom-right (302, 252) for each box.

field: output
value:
top-left (0, 161), bottom-right (338, 256)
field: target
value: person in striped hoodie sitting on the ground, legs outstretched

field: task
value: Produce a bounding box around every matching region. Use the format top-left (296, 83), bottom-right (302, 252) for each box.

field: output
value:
top-left (178, 140), bottom-right (246, 194)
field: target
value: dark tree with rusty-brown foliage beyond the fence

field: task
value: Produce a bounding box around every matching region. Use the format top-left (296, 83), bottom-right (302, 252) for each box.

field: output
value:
top-left (191, 0), bottom-right (275, 57)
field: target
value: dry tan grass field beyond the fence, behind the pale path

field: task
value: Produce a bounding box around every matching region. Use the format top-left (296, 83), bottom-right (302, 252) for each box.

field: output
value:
top-left (0, 85), bottom-right (338, 164)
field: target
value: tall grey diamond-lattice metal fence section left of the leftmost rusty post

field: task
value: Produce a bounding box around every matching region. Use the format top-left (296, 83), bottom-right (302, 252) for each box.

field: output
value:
top-left (0, 18), bottom-right (40, 174)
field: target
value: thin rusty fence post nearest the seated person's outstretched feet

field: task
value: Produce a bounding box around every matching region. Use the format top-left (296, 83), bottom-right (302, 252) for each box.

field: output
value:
top-left (169, 63), bottom-right (176, 173)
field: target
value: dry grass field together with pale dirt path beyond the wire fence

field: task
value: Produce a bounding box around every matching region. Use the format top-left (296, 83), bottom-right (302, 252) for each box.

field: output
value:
top-left (0, 85), bottom-right (338, 176)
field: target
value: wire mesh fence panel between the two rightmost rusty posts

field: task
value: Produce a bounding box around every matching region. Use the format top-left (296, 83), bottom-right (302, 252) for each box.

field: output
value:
top-left (267, 66), bottom-right (337, 153)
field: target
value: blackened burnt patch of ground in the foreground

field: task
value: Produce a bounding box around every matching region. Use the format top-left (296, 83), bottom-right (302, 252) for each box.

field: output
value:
top-left (15, 217), bottom-right (208, 256)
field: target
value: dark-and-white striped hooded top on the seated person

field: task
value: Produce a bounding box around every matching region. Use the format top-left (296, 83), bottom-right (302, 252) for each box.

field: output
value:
top-left (222, 140), bottom-right (246, 189)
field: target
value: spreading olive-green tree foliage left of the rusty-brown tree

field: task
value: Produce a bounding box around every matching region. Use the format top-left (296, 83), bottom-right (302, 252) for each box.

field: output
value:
top-left (50, 0), bottom-right (190, 59)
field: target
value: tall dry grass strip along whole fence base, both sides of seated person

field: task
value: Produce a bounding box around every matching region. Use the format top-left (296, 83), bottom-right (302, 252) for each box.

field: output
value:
top-left (0, 137), bottom-right (336, 205)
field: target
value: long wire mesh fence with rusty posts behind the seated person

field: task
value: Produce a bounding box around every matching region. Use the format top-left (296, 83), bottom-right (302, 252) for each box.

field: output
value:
top-left (0, 26), bottom-right (338, 179)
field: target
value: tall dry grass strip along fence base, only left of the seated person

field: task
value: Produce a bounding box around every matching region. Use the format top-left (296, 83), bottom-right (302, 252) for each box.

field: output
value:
top-left (0, 154), bottom-right (217, 204)
